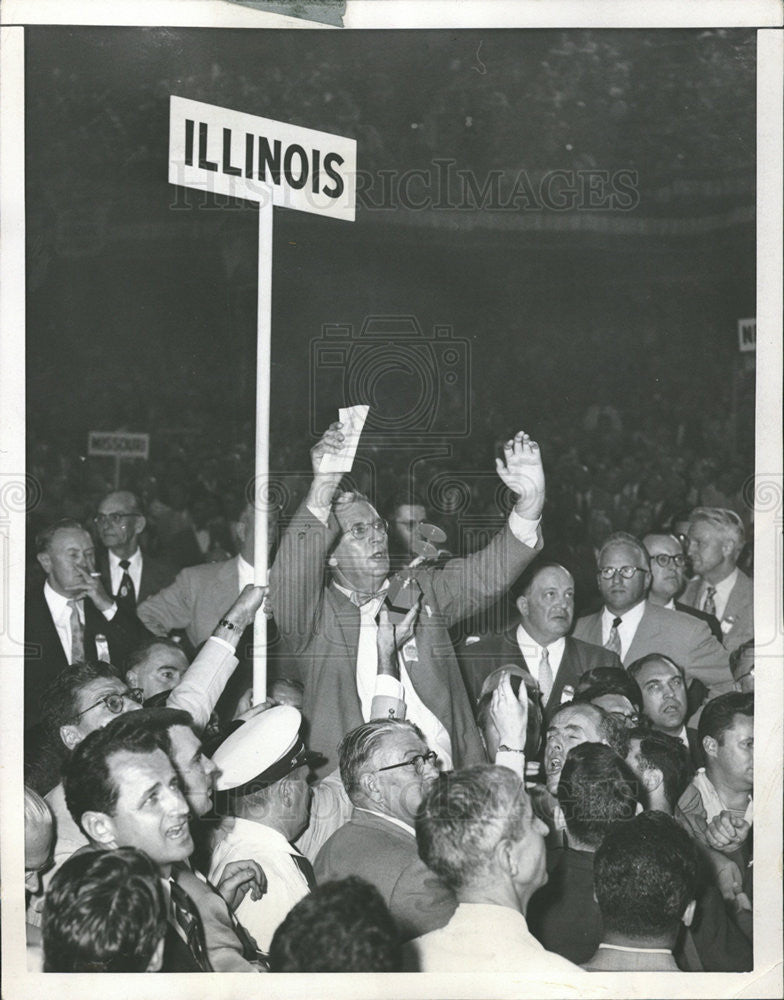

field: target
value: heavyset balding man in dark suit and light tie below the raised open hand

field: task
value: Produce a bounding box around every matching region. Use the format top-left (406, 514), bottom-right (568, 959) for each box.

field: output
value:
top-left (458, 563), bottom-right (621, 723)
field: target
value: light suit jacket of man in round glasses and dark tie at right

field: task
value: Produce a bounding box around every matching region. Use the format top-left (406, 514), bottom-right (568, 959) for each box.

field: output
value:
top-left (574, 601), bottom-right (732, 690)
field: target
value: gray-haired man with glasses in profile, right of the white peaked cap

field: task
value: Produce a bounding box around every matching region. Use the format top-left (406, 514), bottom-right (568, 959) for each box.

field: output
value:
top-left (314, 719), bottom-right (457, 941)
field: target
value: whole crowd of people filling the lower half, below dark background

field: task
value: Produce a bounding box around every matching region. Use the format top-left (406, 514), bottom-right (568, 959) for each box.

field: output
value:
top-left (24, 424), bottom-right (754, 978)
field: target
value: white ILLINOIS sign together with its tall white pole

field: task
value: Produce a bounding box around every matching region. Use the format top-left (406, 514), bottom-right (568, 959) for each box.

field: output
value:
top-left (169, 96), bottom-right (357, 705)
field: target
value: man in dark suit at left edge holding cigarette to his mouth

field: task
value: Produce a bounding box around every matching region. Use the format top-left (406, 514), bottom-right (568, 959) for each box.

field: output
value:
top-left (25, 519), bottom-right (149, 728)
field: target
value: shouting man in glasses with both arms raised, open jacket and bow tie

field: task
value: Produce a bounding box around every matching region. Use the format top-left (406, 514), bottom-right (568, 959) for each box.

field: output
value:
top-left (270, 423), bottom-right (544, 775)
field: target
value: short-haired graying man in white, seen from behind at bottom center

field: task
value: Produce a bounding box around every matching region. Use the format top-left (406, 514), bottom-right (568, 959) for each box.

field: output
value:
top-left (406, 765), bottom-right (576, 978)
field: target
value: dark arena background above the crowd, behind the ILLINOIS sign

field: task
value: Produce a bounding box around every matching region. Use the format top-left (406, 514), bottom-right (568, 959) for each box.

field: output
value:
top-left (25, 27), bottom-right (756, 607)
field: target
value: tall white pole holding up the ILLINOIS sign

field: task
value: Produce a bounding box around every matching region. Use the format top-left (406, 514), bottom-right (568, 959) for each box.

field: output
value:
top-left (253, 190), bottom-right (272, 705)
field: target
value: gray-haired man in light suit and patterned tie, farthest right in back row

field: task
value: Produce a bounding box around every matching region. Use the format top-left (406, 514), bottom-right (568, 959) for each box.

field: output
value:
top-left (682, 507), bottom-right (754, 650)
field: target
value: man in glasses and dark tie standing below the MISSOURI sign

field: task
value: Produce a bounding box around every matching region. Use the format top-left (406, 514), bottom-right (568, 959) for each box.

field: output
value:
top-left (95, 490), bottom-right (176, 610)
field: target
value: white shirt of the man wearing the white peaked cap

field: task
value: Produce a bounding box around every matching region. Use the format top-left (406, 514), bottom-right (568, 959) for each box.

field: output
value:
top-left (209, 819), bottom-right (310, 952)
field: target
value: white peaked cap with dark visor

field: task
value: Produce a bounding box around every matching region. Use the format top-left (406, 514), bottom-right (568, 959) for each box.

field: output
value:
top-left (212, 705), bottom-right (318, 795)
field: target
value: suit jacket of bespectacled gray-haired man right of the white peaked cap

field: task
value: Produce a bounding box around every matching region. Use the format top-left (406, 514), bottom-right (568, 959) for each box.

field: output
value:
top-left (313, 810), bottom-right (457, 941)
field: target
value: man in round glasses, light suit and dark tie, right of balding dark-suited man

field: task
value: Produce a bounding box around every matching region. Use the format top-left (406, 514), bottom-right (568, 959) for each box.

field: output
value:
top-left (574, 531), bottom-right (732, 694)
